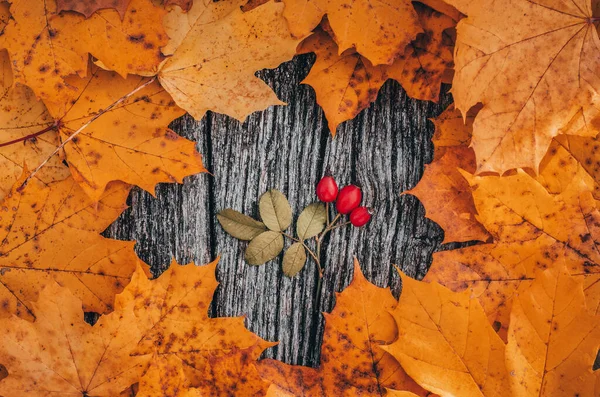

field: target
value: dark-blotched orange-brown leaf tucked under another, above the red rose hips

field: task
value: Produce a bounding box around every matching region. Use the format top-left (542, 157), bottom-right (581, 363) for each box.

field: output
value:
top-left (298, 3), bottom-right (456, 135)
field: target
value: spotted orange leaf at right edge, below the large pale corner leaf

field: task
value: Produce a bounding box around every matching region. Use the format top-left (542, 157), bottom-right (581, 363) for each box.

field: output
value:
top-left (425, 171), bottom-right (600, 337)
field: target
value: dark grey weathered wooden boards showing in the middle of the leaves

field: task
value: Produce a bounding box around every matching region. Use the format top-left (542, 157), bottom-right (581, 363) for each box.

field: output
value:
top-left (106, 55), bottom-right (449, 366)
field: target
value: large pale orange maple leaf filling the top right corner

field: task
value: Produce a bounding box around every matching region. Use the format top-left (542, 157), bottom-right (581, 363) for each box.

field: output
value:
top-left (447, 0), bottom-right (600, 174)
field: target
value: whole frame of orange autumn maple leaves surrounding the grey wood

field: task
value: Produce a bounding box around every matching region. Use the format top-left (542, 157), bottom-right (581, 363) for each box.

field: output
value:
top-left (0, 0), bottom-right (600, 397)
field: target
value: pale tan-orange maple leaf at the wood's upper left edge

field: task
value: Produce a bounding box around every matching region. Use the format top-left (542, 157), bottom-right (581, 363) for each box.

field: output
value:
top-left (158, 1), bottom-right (300, 121)
